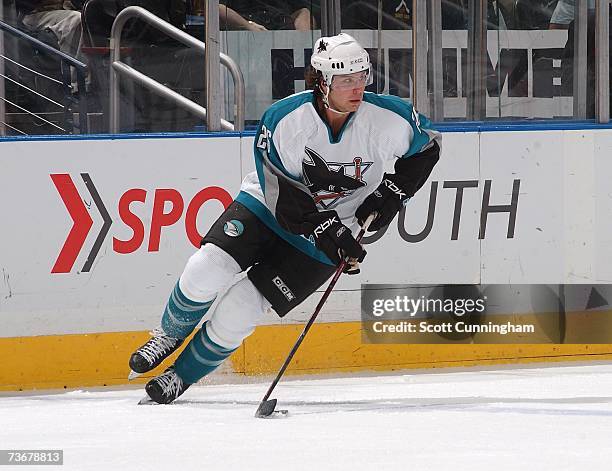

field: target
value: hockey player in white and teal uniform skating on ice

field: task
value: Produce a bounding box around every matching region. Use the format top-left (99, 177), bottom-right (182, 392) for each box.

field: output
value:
top-left (130, 33), bottom-right (441, 404)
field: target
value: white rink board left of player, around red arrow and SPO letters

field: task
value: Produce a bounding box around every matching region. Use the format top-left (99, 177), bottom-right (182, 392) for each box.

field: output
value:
top-left (0, 138), bottom-right (240, 337)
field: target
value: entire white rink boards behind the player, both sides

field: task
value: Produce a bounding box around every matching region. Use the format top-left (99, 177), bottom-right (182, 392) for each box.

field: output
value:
top-left (0, 130), bottom-right (612, 337)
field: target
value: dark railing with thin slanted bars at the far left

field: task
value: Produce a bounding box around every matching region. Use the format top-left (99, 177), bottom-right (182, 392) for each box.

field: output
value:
top-left (0, 17), bottom-right (89, 134)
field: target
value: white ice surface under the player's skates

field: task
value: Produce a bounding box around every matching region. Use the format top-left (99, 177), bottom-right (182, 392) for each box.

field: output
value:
top-left (0, 363), bottom-right (612, 471)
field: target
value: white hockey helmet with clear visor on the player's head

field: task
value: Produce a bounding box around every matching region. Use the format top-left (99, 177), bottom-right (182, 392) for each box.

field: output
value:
top-left (310, 33), bottom-right (372, 87)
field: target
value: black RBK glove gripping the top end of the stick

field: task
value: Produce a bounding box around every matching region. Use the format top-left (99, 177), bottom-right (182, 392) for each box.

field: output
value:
top-left (355, 173), bottom-right (410, 232)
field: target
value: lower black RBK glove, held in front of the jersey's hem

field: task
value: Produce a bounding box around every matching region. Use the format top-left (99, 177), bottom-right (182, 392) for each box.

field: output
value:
top-left (308, 211), bottom-right (366, 273)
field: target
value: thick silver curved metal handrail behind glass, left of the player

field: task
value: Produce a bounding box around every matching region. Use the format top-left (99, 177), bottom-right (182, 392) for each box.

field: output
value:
top-left (110, 6), bottom-right (245, 133)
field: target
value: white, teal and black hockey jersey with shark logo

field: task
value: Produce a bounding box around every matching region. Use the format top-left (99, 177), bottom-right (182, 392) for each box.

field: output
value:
top-left (236, 91), bottom-right (441, 264)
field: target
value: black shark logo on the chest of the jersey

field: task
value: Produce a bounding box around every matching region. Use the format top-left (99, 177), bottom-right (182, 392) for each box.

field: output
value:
top-left (302, 147), bottom-right (373, 209)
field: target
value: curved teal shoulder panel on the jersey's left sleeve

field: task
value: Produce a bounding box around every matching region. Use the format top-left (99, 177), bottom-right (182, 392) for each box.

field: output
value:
top-left (253, 92), bottom-right (314, 194)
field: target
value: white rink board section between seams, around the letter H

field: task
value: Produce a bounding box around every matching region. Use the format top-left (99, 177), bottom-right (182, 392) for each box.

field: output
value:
top-left (480, 132), bottom-right (564, 283)
